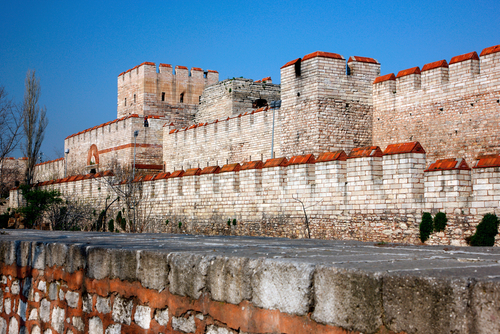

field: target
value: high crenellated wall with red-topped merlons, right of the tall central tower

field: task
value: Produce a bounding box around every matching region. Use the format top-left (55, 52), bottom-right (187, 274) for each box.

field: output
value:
top-left (373, 46), bottom-right (500, 163)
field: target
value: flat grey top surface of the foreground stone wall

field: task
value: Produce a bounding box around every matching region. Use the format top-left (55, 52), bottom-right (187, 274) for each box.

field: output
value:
top-left (0, 230), bottom-right (500, 282)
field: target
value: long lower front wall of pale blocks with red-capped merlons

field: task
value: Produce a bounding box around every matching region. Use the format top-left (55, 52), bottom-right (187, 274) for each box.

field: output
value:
top-left (11, 143), bottom-right (500, 246)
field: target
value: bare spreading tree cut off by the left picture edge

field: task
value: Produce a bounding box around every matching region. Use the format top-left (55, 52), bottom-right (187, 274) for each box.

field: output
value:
top-left (0, 86), bottom-right (21, 194)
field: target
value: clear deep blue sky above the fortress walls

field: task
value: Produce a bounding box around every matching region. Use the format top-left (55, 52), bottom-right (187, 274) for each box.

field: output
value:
top-left (0, 0), bottom-right (500, 160)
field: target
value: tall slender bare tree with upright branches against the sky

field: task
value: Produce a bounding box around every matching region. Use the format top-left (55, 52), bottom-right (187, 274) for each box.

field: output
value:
top-left (22, 70), bottom-right (48, 184)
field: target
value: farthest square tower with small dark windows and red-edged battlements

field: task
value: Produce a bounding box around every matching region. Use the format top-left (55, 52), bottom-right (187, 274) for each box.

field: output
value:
top-left (117, 62), bottom-right (219, 122)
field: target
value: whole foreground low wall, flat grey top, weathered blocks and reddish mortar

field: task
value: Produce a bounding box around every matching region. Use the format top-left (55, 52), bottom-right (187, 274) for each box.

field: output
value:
top-left (0, 230), bottom-right (500, 334)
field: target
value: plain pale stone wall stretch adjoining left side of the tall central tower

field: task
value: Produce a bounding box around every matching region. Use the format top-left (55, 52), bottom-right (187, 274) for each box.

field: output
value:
top-left (163, 108), bottom-right (281, 171)
